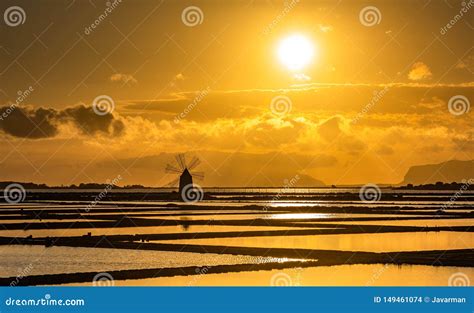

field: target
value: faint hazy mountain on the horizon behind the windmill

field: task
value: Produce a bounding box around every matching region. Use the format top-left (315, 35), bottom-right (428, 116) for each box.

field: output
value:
top-left (95, 151), bottom-right (326, 188)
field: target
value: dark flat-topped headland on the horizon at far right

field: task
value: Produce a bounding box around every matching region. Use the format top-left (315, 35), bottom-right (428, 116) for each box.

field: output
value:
top-left (401, 160), bottom-right (474, 185)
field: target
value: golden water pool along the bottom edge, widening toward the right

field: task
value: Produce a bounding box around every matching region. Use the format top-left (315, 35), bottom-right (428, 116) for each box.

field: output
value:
top-left (97, 264), bottom-right (474, 286)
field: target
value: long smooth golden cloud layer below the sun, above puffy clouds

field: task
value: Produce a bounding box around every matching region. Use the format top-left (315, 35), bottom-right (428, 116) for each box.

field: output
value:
top-left (120, 82), bottom-right (474, 123)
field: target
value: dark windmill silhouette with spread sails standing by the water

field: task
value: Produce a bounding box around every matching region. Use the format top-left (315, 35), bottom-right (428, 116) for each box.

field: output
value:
top-left (165, 154), bottom-right (204, 202)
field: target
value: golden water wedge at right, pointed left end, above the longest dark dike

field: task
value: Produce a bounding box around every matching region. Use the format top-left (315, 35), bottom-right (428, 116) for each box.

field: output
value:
top-left (158, 232), bottom-right (474, 252)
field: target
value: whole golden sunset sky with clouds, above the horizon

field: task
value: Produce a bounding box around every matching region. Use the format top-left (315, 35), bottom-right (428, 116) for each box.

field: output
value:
top-left (0, 0), bottom-right (474, 186)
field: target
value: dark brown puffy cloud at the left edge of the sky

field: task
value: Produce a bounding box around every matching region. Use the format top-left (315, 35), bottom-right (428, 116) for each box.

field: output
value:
top-left (0, 105), bottom-right (125, 139)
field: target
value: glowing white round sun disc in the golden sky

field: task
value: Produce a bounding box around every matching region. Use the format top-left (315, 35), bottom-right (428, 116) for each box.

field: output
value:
top-left (277, 34), bottom-right (315, 71)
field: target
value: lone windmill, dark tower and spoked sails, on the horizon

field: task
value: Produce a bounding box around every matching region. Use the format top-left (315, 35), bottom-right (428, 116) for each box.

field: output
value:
top-left (166, 154), bottom-right (204, 201)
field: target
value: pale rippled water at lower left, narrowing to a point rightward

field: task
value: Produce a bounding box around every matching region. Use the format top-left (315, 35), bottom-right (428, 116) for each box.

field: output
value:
top-left (0, 246), bottom-right (296, 277)
